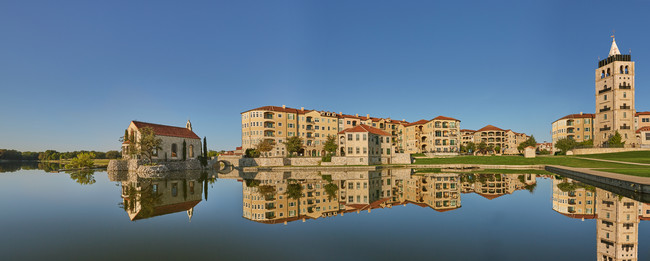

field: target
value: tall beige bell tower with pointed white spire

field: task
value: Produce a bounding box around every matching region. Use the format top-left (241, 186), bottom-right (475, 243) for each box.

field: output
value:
top-left (594, 39), bottom-right (636, 146)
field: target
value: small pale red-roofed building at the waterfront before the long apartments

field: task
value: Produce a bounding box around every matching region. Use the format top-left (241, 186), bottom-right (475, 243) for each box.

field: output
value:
top-left (338, 125), bottom-right (392, 165)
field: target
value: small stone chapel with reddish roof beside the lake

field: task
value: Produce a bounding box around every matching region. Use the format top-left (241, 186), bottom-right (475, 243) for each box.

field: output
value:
top-left (122, 120), bottom-right (201, 160)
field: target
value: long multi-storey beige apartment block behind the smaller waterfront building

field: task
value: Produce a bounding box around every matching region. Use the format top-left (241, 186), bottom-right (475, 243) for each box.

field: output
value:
top-left (241, 105), bottom-right (460, 157)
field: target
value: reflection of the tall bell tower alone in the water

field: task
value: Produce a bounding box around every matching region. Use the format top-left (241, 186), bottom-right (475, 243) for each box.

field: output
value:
top-left (596, 189), bottom-right (639, 261)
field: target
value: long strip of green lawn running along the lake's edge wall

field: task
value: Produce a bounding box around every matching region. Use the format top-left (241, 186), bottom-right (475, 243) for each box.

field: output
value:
top-left (415, 156), bottom-right (639, 169)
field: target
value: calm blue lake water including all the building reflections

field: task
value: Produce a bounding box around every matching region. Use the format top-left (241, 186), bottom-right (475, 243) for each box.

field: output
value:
top-left (0, 163), bottom-right (650, 260)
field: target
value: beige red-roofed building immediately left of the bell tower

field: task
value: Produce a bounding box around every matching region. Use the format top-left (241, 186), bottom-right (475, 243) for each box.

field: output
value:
top-left (551, 112), bottom-right (595, 148)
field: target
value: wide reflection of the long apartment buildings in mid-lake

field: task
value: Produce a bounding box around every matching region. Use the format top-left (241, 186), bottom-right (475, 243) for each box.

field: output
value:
top-left (230, 169), bottom-right (536, 224)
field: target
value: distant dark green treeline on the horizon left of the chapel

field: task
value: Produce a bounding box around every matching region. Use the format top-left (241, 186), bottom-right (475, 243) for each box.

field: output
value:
top-left (0, 149), bottom-right (122, 160)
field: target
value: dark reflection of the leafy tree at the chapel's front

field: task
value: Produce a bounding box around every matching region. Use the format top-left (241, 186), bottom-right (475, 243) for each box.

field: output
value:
top-left (120, 184), bottom-right (162, 218)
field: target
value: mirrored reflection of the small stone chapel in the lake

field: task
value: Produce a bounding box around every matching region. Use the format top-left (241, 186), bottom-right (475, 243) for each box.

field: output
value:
top-left (109, 172), bottom-right (207, 221)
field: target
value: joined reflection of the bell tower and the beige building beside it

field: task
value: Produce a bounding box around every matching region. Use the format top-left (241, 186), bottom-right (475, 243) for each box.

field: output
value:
top-left (552, 176), bottom-right (650, 261)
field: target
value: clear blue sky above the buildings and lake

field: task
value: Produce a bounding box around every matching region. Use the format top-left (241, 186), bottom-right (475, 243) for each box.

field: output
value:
top-left (0, 0), bottom-right (650, 151)
